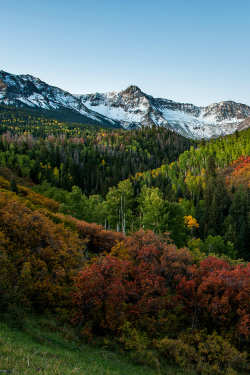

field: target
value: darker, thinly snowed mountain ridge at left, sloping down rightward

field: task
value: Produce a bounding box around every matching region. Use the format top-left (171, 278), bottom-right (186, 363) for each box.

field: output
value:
top-left (0, 70), bottom-right (121, 128)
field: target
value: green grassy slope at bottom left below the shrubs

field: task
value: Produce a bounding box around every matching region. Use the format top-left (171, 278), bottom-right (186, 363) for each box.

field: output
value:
top-left (0, 316), bottom-right (196, 375)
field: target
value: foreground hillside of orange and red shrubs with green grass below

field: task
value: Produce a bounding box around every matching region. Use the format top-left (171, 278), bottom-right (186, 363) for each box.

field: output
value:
top-left (0, 178), bottom-right (249, 375)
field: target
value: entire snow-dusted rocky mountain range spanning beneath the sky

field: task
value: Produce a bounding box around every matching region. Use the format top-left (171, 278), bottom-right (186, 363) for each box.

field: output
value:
top-left (0, 71), bottom-right (250, 139)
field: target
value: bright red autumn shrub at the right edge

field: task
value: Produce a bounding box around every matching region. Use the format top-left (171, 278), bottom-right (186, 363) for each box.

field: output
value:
top-left (177, 256), bottom-right (250, 342)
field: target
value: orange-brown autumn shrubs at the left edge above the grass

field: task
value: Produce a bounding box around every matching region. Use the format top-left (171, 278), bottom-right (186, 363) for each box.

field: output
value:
top-left (0, 193), bottom-right (85, 311)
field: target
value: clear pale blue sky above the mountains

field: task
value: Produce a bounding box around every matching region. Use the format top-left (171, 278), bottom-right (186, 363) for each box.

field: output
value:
top-left (0, 0), bottom-right (250, 105)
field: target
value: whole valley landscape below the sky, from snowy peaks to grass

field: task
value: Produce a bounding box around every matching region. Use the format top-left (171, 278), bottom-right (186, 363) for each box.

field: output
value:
top-left (0, 67), bottom-right (250, 375)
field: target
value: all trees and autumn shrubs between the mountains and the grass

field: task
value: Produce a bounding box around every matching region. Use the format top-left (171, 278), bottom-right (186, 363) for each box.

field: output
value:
top-left (0, 106), bottom-right (250, 375)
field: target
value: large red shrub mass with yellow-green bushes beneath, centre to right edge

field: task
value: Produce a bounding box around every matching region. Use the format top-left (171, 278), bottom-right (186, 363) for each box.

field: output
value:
top-left (73, 230), bottom-right (250, 375)
